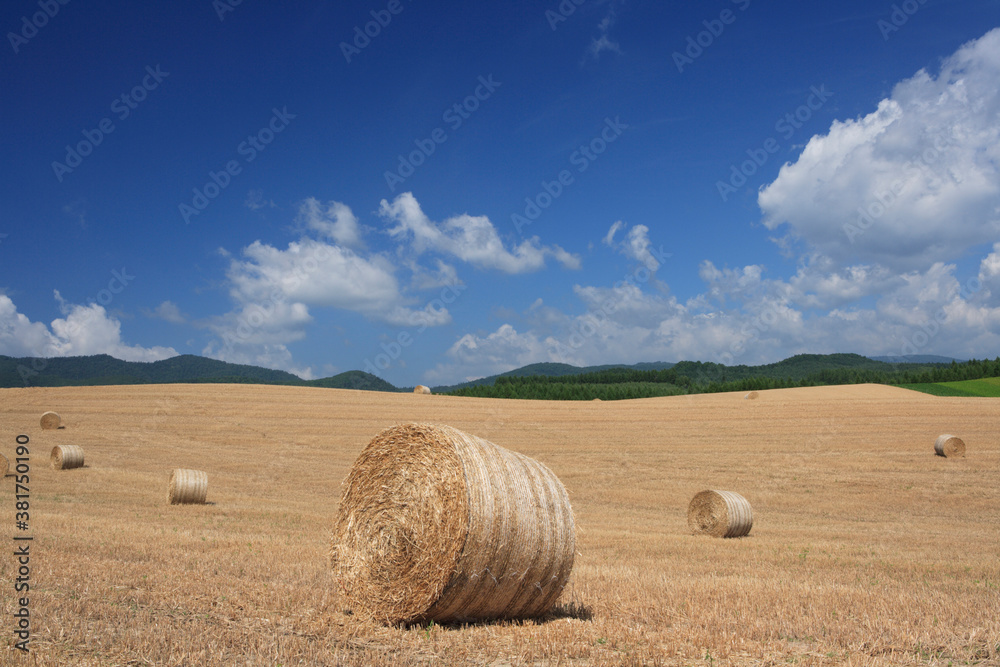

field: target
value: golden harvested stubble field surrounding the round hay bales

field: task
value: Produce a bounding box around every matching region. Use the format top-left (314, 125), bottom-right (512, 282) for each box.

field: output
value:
top-left (0, 385), bottom-right (1000, 666)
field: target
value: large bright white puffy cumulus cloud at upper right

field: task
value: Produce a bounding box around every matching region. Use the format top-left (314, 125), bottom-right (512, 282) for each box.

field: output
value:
top-left (758, 29), bottom-right (1000, 270)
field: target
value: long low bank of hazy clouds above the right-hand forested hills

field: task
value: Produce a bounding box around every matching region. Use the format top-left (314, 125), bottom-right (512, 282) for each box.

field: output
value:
top-left (426, 250), bottom-right (1000, 384)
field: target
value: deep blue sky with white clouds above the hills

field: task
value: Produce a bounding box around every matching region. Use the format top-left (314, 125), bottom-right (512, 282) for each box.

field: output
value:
top-left (0, 0), bottom-right (1000, 385)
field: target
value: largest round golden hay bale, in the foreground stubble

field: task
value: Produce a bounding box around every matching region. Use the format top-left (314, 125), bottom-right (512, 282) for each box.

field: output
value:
top-left (330, 424), bottom-right (576, 623)
